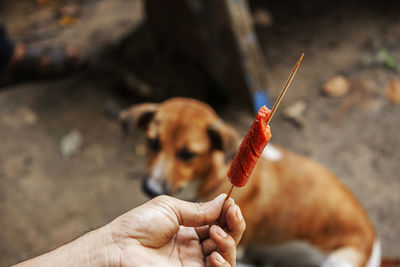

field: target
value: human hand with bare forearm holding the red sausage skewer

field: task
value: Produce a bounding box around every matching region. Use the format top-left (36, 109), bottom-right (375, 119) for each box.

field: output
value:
top-left (14, 194), bottom-right (246, 267)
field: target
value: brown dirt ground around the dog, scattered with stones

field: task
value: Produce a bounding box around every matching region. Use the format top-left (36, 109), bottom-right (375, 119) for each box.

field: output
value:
top-left (0, 0), bottom-right (400, 266)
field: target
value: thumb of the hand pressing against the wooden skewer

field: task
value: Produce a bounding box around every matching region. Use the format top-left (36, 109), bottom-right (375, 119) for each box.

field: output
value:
top-left (154, 194), bottom-right (226, 227)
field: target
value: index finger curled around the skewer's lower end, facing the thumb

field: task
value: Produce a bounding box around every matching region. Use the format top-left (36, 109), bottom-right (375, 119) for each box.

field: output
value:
top-left (225, 204), bottom-right (246, 244)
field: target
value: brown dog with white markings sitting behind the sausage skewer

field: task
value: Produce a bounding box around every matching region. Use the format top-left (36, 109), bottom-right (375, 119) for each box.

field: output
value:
top-left (120, 98), bottom-right (380, 266)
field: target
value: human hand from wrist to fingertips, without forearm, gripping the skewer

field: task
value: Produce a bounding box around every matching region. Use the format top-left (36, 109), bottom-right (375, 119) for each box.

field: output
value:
top-left (105, 194), bottom-right (245, 266)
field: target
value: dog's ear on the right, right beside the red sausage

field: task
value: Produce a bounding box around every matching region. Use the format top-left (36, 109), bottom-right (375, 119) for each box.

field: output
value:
top-left (207, 121), bottom-right (239, 162)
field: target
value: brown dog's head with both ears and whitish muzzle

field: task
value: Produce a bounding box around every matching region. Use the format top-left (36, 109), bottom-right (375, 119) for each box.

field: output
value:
top-left (120, 98), bottom-right (238, 196)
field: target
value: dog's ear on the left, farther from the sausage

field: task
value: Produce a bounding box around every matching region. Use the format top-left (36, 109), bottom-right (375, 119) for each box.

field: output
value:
top-left (119, 103), bottom-right (159, 134)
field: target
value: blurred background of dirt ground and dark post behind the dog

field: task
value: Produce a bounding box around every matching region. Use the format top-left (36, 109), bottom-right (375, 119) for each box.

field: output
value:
top-left (0, 0), bottom-right (400, 266)
